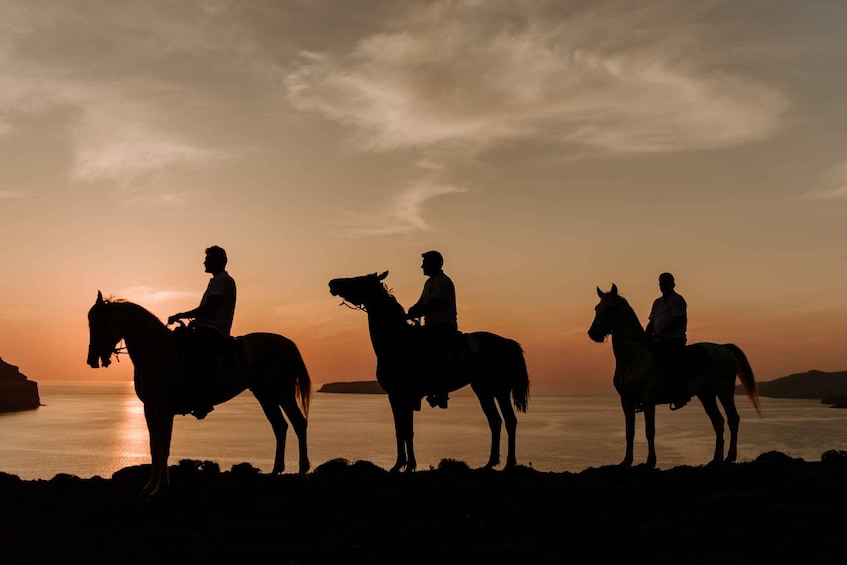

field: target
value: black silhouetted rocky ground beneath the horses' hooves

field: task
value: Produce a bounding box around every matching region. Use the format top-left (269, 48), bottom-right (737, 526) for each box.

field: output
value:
top-left (0, 451), bottom-right (847, 565)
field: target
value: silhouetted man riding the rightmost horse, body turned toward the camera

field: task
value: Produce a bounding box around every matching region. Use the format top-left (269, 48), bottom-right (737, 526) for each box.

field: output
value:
top-left (646, 273), bottom-right (691, 410)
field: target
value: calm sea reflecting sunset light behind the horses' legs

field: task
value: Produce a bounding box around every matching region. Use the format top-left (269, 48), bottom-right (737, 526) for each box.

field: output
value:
top-left (0, 382), bottom-right (847, 479)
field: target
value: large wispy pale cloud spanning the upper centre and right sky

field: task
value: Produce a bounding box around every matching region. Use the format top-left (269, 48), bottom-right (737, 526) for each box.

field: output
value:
top-left (285, 0), bottom-right (788, 153)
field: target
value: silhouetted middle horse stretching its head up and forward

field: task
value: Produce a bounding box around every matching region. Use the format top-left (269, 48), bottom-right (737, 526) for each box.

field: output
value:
top-left (329, 271), bottom-right (529, 472)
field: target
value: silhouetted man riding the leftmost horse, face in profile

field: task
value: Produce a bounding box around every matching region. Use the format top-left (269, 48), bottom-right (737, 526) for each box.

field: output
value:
top-left (168, 245), bottom-right (236, 420)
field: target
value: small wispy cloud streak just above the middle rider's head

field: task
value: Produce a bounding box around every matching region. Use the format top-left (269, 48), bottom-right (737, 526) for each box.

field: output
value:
top-left (338, 181), bottom-right (466, 237)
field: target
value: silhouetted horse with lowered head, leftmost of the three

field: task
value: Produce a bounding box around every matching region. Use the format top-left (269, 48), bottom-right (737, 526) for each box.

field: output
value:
top-left (88, 292), bottom-right (312, 495)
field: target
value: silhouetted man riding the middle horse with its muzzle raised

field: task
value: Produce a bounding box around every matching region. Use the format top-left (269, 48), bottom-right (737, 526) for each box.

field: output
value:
top-left (406, 251), bottom-right (459, 408)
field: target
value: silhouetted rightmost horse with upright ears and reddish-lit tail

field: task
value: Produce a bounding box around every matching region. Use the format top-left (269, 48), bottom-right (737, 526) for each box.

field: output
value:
top-left (588, 284), bottom-right (761, 467)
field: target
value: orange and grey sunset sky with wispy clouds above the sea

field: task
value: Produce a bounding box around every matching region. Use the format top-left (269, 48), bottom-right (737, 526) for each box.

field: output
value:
top-left (0, 0), bottom-right (847, 392)
